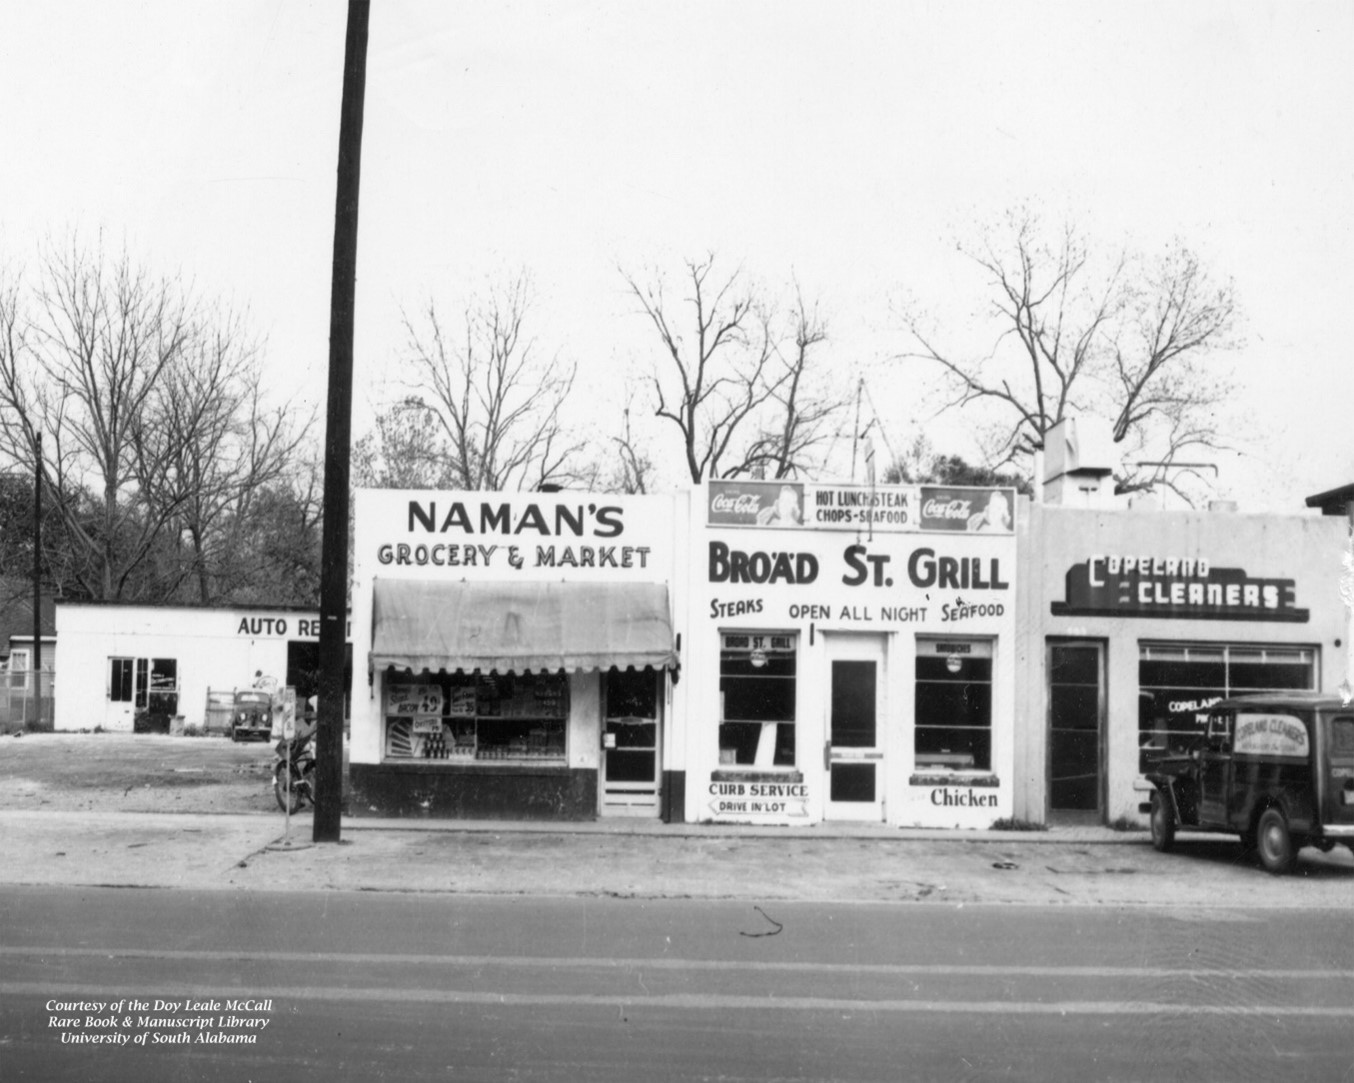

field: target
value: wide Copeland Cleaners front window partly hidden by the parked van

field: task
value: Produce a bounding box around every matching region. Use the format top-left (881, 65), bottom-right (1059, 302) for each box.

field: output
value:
top-left (1137, 643), bottom-right (1316, 772)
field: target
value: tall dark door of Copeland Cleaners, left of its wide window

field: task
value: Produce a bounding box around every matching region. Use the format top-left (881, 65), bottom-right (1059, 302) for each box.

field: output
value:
top-left (1047, 642), bottom-right (1105, 815)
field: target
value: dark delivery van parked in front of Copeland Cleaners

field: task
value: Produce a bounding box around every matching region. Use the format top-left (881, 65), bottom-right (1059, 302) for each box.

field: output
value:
top-left (1140, 692), bottom-right (1354, 873)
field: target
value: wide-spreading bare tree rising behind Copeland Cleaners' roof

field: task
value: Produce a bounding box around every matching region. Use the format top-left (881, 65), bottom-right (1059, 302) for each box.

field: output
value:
top-left (904, 210), bottom-right (1238, 495)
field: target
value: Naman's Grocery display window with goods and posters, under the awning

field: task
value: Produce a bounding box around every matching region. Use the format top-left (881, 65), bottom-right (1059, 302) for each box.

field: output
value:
top-left (385, 673), bottom-right (569, 765)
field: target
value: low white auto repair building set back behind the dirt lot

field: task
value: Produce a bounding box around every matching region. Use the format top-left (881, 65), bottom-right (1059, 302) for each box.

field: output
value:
top-left (54, 600), bottom-right (349, 732)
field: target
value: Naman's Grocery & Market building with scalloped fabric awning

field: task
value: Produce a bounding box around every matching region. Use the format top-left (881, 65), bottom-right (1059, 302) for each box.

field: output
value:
top-left (349, 490), bottom-right (686, 820)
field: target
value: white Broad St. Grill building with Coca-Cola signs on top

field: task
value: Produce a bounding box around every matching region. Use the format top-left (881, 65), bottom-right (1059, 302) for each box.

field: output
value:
top-left (682, 482), bottom-right (1017, 828)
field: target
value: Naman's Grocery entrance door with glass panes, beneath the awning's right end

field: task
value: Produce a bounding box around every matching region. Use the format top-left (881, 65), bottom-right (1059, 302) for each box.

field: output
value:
top-left (598, 669), bottom-right (662, 816)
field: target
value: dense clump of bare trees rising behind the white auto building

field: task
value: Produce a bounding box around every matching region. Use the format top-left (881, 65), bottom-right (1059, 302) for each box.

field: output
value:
top-left (0, 238), bottom-right (309, 602)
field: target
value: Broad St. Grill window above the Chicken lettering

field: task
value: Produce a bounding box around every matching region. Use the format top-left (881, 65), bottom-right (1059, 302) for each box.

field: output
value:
top-left (915, 639), bottom-right (992, 770)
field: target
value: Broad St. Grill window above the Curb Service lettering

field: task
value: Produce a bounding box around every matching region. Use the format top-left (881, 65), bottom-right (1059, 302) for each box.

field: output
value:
top-left (719, 632), bottom-right (796, 768)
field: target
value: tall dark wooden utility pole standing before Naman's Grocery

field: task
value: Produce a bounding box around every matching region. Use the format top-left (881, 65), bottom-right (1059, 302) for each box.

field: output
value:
top-left (313, 0), bottom-right (371, 842)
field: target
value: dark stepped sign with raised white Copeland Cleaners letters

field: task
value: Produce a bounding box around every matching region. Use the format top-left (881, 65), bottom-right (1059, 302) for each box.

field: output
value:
top-left (1051, 554), bottom-right (1308, 623)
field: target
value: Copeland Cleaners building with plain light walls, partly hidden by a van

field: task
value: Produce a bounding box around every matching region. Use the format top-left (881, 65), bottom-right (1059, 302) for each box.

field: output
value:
top-left (1016, 502), bottom-right (1347, 823)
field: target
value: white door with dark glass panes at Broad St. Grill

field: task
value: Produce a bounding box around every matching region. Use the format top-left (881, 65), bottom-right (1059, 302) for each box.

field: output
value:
top-left (823, 634), bottom-right (887, 820)
